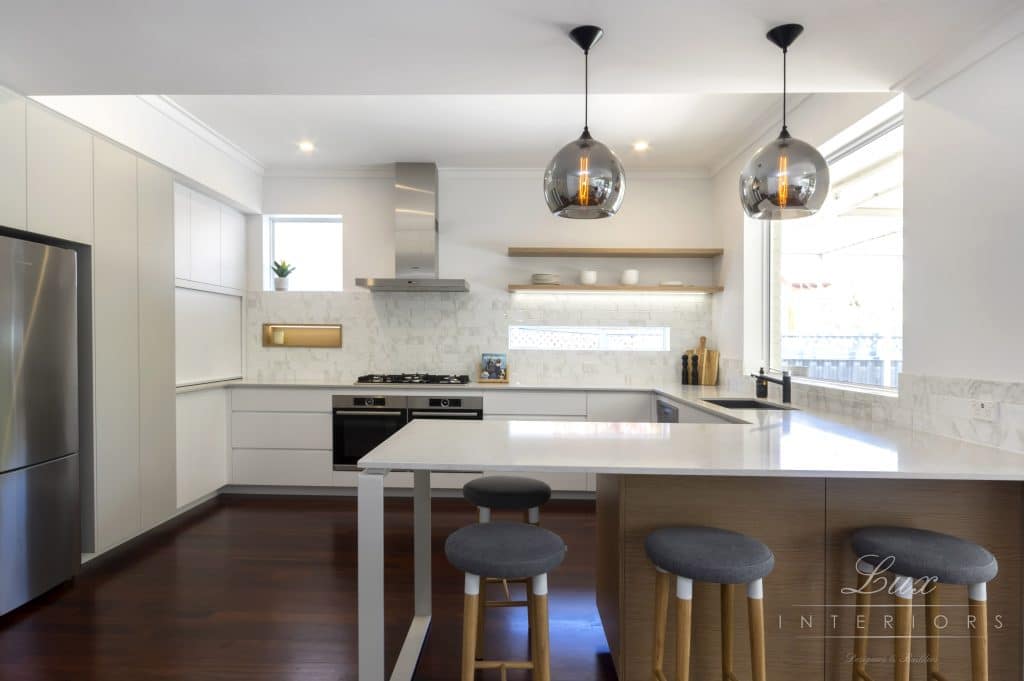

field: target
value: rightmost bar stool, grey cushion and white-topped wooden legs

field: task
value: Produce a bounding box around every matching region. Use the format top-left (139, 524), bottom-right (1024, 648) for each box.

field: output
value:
top-left (851, 526), bottom-right (999, 681)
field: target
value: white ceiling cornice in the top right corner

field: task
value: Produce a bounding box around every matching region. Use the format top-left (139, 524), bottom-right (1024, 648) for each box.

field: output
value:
top-left (892, 3), bottom-right (1024, 99)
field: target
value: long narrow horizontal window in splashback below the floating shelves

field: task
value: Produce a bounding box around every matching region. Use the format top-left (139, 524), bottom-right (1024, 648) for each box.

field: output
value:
top-left (509, 326), bottom-right (671, 352)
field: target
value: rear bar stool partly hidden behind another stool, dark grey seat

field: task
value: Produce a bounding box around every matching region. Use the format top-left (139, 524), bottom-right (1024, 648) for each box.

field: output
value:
top-left (462, 475), bottom-right (551, 657)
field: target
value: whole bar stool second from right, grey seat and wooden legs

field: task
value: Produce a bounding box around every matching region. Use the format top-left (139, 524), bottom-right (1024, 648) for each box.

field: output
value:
top-left (645, 526), bottom-right (775, 681)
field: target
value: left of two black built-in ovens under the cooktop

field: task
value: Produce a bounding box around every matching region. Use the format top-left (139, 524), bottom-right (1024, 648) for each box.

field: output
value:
top-left (332, 395), bottom-right (409, 470)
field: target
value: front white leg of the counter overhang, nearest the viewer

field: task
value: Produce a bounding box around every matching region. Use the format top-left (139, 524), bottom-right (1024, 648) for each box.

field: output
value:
top-left (356, 470), bottom-right (388, 681)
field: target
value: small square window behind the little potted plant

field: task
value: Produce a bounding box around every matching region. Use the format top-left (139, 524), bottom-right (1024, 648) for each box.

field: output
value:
top-left (265, 216), bottom-right (344, 291)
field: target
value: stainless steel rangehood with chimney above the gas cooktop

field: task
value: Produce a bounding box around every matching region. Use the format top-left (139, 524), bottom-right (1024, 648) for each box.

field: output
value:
top-left (355, 163), bottom-right (469, 293)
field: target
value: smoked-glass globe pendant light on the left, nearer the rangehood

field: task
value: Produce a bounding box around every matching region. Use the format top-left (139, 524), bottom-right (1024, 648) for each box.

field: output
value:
top-left (544, 26), bottom-right (626, 219)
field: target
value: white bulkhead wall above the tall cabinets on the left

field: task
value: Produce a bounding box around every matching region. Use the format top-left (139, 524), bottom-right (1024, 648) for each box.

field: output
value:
top-left (33, 95), bottom-right (263, 213)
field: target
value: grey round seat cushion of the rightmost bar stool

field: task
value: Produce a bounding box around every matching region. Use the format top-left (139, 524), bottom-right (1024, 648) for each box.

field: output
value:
top-left (851, 526), bottom-right (999, 585)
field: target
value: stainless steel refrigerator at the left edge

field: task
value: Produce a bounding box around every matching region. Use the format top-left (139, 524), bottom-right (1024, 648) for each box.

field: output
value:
top-left (0, 237), bottom-right (81, 614)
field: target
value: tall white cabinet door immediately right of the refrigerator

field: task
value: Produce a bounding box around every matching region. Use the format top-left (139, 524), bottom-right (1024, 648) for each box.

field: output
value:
top-left (89, 139), bottom-right (141, 550)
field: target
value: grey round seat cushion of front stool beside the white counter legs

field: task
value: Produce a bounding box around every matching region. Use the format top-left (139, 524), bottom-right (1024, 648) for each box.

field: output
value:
top-left (444, 522), bottom-right (565, 580)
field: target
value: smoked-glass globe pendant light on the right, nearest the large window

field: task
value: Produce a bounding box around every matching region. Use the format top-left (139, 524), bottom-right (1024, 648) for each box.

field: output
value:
top-left (739, 24), bottom-right (828, 220)
